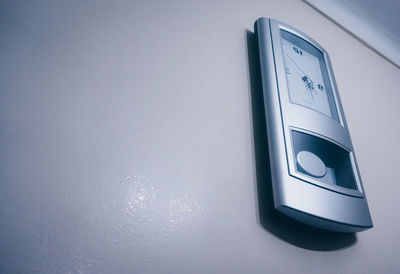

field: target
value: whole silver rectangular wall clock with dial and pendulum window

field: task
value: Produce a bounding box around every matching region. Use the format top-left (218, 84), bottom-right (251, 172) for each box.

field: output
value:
top-left (255, 18), bottom-right (372, 232)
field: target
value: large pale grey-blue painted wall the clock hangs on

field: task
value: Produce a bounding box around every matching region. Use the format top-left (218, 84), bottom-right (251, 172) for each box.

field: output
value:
top-left (0, 0), bottom-right (400, 273)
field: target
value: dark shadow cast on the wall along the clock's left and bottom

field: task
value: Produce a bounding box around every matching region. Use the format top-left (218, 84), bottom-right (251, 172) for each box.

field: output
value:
top-left (245, 29), bottom-right (357, 251)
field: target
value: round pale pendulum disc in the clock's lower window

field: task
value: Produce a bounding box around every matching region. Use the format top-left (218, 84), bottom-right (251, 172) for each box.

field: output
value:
top-left (296, 150), bottom-right (326, 178)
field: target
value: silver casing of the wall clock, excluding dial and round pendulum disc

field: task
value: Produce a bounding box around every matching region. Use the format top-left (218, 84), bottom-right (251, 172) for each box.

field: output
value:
top-left (255, 18), bottom-right (373, 232)
